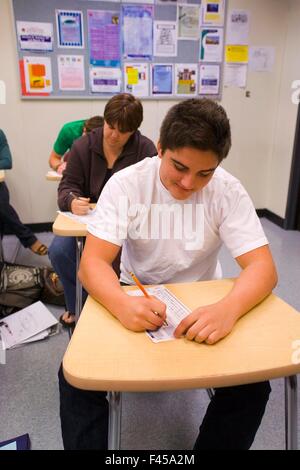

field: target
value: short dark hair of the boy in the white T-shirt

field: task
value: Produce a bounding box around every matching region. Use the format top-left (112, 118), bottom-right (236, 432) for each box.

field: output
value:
top-left (159, 98), bottom-right (231, 162)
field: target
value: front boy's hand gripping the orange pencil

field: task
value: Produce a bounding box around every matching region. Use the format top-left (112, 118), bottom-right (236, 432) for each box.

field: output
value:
top-left (118, 295), bottom-right (166, 331)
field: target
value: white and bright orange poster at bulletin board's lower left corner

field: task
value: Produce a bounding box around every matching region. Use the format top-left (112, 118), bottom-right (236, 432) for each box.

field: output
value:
top-left (21, 57), bottom-right (53, 95)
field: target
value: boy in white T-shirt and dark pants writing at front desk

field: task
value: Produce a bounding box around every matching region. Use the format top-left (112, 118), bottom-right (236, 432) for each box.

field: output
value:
top-left (59, 99), bottom-right (277, 450)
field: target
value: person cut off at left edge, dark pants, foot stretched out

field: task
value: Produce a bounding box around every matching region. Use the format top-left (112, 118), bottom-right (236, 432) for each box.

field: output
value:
top-left (0, 129), bottom-right (48, 256)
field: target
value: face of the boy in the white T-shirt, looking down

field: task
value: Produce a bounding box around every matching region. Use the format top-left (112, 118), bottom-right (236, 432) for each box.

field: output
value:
top-left (158, 143), bottom-right (219, 200)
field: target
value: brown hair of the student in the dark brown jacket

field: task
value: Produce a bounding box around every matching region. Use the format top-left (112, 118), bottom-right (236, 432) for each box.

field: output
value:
top-left (104, 93), bottom-right (143, 132)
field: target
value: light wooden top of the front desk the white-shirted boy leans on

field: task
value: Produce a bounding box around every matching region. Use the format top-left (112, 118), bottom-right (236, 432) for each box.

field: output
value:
top-left (63, 279), bottom-right (300, 391)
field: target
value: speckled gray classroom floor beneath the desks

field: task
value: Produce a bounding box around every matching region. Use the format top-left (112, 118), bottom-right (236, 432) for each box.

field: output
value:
top-left (0, 219), bottom-right (300, 450)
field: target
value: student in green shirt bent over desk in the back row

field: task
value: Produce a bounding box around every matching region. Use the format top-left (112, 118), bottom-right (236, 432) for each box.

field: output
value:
top-left (49, 116), bottom-right (104, 174)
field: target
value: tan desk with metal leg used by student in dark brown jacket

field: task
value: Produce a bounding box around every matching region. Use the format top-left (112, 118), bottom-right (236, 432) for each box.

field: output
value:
top-left (52, 214), bottom-right (87, 319)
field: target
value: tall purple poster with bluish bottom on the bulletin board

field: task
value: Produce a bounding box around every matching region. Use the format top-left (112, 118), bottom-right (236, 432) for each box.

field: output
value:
top-left (87, 10), bottom-right (121, 67)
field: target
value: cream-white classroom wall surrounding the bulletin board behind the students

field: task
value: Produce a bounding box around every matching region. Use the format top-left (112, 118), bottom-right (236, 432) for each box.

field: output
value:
top-left (0, 0), bottom-right (300, 223)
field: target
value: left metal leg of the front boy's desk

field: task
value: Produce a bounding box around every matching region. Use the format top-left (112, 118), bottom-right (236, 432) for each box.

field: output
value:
top-left (108, 392), bottom-right (122, 450)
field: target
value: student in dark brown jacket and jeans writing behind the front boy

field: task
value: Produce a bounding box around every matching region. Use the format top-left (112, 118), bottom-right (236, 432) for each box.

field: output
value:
top-left (49, 93), bottom-right (157, 327)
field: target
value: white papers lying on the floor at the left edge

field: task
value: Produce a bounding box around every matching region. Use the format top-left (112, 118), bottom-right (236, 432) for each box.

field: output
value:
top-left (0, 302), bottom-right (58, 349)
